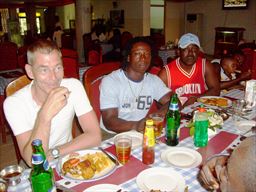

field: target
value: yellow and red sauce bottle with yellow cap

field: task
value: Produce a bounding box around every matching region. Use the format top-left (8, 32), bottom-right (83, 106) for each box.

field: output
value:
top-left (142, 119), bottom-right (155, 165)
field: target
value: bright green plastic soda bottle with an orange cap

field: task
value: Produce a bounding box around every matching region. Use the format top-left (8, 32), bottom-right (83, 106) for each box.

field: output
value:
top-left (194, 105), bottom-right (209, 147)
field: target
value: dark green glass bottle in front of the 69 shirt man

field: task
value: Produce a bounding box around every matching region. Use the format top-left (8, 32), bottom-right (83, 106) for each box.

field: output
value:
top-left (165, 94), bottom-right (180, 146)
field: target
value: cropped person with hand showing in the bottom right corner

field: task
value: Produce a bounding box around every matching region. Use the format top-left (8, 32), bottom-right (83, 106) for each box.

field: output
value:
top-left (199, 135), bottom-right (256, 192)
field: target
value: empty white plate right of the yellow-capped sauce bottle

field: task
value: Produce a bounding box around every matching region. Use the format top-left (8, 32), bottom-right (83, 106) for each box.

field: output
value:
top-left (161, 147), bottom-right (202, 168)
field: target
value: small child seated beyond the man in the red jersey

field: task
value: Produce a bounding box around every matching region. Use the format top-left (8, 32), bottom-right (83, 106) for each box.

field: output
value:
top-left (214, 56), bottom-right (251, 90)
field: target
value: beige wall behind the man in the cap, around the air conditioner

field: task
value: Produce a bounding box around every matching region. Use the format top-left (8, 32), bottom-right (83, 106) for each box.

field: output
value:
top-left (166, 0), bottom-right (256, 54)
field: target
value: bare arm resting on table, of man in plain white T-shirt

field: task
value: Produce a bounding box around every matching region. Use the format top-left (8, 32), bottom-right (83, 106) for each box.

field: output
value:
top-left (53, 110), bottom-right (101, 158)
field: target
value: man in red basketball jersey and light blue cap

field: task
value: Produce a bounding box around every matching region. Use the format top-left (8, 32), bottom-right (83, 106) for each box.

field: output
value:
top-left (159, 33), bottom-right (220, 106)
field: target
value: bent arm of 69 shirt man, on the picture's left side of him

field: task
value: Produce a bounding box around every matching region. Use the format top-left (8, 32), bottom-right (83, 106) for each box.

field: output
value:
top-left (101, 108), bottom-right (145, 133)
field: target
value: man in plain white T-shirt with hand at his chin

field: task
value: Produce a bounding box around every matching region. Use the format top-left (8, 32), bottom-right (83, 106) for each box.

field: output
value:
top-left (4, 40), bottom-right (101, 165)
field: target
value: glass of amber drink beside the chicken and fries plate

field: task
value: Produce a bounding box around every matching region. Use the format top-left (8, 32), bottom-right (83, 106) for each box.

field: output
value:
top-left (114, 135), bottom-right (132, 164)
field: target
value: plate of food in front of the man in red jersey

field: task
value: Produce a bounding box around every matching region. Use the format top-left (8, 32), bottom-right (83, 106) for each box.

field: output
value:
top-left (197, 96), bottom-right (232, 107)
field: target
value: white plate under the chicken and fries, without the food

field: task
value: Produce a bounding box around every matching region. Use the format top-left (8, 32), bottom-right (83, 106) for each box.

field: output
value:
top-left (56, 149), bottom-right (117, 182)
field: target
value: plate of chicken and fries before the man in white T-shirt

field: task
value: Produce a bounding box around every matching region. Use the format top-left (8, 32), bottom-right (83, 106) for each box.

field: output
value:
top-left (56, 149), bottom-right (117, 182)
